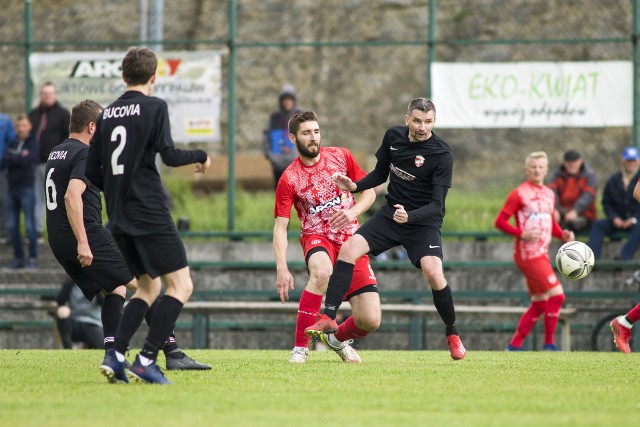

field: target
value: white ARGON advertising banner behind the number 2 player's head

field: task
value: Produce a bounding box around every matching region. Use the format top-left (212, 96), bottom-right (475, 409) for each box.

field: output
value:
top-left (29, 51), bottom-right (222, 142)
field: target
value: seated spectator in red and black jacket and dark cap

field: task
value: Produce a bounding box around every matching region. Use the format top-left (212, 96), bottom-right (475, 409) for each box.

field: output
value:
top-left (547, 150), bottom-right (597, 232)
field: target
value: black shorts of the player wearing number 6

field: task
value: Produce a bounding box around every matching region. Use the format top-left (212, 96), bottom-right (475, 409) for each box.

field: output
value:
top-left (51, 239), bottom-right (133, 300)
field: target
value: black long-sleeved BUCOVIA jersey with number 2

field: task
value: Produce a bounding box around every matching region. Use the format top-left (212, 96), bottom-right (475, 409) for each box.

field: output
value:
top-left (85, 91), bottom-right (206, 236)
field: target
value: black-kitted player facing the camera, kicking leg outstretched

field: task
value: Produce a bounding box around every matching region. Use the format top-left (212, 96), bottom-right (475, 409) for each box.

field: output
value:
top-left (306, 98), bottom-right (466, 360)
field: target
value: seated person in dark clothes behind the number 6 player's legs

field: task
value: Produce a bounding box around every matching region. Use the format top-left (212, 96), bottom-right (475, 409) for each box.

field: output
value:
top-left (56, 278), bottom-right (104, 349)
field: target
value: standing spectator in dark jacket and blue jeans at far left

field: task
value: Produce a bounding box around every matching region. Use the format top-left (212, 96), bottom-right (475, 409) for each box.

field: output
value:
top-left (2, 114), bottom-right (38, 269)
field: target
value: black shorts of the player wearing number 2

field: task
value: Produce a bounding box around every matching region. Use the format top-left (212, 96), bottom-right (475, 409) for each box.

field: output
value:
top-left (113, 228), bottom-right (188, 279)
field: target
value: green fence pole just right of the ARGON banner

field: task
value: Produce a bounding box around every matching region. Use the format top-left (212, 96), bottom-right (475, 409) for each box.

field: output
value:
top-left (227, 0), bottom-right (238, 231)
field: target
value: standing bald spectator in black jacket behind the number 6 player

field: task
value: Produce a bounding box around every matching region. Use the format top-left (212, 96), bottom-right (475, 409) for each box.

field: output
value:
top-left (29, 82), bottom-right (71, 237)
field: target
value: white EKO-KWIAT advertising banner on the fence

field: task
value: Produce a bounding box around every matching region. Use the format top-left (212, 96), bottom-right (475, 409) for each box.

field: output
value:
top-left (431, 61), bottom-right (633, 128)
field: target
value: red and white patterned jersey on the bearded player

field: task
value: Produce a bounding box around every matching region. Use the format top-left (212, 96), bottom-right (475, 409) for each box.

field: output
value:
top-left (274, 147), bottom-right (366, 244)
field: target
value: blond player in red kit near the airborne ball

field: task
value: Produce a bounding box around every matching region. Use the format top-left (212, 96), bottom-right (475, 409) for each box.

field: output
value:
top-left (495, 151), bottom-right (575, 351)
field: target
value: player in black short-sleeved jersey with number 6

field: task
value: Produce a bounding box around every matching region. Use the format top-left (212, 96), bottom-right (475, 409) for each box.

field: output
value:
top-left (43, 100), bottom-right (211, 382)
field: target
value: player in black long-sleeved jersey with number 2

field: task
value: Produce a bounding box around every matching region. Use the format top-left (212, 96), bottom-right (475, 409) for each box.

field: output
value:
top-left (85, 47), bottom-right (211, 384)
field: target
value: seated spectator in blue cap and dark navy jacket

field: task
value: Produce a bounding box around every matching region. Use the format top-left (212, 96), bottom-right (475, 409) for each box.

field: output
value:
top-left (587, 147), bottom-right (640, 260)
